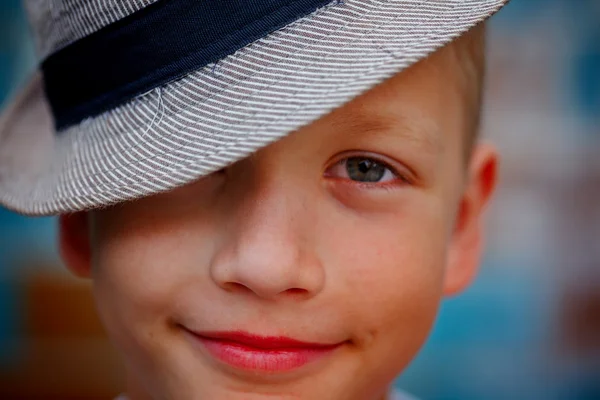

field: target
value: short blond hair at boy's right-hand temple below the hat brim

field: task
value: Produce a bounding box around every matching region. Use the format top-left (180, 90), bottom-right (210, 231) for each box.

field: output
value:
top-left (441, 22), bottom-right (486, 158)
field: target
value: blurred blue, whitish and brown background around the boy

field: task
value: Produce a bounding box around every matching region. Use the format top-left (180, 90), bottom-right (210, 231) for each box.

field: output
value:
top-left (0, 0), bottom-right (600, 400)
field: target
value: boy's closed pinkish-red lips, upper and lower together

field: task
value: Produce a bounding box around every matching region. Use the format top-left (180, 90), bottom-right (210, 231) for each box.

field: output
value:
top-left (186, 329), bottom-right (342, 373)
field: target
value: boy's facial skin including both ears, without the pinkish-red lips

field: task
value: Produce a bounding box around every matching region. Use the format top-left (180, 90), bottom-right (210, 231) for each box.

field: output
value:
top-left (60, 39), bottom-right (496, 400)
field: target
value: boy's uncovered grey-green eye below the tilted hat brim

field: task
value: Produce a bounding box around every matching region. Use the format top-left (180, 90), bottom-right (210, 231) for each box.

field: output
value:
top-left (326, 157), bottom-right (399, 183)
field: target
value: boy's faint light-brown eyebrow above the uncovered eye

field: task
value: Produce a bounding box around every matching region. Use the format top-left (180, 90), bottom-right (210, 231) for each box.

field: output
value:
top-left (335, 110), bottom-right (442, 153)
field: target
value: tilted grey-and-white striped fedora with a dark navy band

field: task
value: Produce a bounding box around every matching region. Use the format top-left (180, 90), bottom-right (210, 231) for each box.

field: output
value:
top-left (0, 0), bottom-right (507, 215)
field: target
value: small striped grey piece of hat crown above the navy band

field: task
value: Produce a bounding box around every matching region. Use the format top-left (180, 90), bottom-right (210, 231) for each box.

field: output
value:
top-left (23, 0), bottom-right (157, 59)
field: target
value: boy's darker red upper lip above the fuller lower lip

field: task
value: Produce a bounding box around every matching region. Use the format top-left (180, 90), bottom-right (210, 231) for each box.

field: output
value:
top-left (192, 331), bottom-right (339, 350)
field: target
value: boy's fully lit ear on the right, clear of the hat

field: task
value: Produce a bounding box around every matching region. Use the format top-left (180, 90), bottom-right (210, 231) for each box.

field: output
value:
top-left (444, 144), bottom-right (498, 296)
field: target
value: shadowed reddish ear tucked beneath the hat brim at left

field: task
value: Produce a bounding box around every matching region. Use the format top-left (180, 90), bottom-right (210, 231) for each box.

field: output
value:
top-left (58, 212), bottom-right (91, 278)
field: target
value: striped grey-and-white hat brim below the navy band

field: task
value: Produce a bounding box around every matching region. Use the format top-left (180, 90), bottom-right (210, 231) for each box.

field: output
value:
top-left (0, 0), bottom-right (507, 215)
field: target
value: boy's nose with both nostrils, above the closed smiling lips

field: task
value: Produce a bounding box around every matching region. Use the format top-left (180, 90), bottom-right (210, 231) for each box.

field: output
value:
top-left (210, 175), bottom-right (325, 300)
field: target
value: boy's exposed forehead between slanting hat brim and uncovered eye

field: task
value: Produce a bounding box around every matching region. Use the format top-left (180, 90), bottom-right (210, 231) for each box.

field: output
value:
top-left (316, 55), bottom-right (466, 158)
